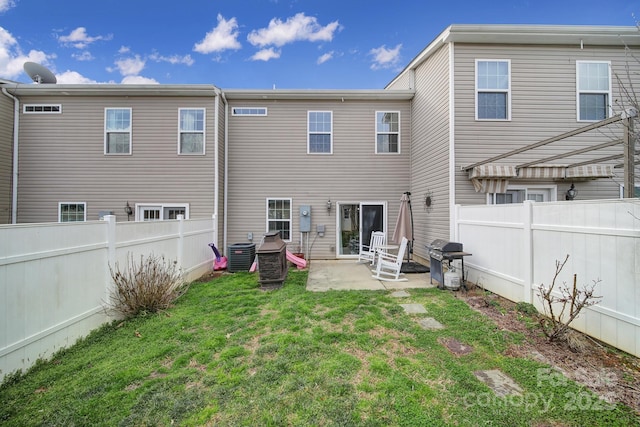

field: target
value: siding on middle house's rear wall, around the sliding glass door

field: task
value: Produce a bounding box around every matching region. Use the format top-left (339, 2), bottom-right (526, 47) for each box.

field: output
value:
top-left (227, 99), bottom-right (411, 259)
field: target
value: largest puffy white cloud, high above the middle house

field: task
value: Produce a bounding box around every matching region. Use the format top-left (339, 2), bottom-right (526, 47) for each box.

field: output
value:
top-left (247, 13), bottom-right (341, 47)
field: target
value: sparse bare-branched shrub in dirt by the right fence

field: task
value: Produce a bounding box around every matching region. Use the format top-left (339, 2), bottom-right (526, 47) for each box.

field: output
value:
top-left (538, 255), bottom-right (602, 341)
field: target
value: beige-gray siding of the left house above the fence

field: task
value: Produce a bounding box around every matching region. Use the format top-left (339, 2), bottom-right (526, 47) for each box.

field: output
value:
top-left (18, 96), bottom-right (215, 222)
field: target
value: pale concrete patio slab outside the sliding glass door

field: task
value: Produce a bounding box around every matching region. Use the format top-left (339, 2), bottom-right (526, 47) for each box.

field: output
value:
top-left (307, 260), bottom-right (434, 292)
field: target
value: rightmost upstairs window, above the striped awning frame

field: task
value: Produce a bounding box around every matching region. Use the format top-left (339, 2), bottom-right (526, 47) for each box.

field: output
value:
top-left (576, 61), bottom-right (611, 121)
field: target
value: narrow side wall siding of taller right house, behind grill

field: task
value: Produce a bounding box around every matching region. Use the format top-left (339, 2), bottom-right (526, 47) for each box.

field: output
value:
top-left (411, 46), bottom-right (450, 258)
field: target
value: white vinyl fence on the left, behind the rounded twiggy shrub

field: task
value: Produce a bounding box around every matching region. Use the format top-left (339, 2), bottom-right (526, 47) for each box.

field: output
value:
top-left (0, 216), bottom-right (216, 381)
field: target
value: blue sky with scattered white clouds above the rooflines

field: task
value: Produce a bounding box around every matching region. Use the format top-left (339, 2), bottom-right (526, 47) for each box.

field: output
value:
top-left (0, 0), bottom-right (640, 89)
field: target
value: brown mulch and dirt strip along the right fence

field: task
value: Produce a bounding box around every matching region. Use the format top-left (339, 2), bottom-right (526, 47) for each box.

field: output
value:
top-left (455, 289), bottom-right (640, 414)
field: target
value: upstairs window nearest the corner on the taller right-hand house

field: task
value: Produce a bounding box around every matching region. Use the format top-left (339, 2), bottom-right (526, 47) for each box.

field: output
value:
top-left (476, 60), bottom-right (511, 120)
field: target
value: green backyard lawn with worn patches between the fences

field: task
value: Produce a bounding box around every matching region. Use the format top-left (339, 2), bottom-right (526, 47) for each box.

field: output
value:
top-left (0, 270), bottom-right (640, 427)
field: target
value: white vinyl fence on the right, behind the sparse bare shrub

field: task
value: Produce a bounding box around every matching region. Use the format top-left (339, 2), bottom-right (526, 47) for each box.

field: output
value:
top-left (454, 199), bottom-right (640, 356)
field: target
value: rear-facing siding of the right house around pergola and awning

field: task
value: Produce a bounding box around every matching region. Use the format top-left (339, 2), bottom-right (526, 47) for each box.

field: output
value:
top-left (455, 43), bottom-right (640, 204)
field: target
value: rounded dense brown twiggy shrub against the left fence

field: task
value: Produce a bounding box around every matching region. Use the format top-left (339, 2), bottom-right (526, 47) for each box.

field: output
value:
top-left (107, 254), bottom-right (187, 318)
